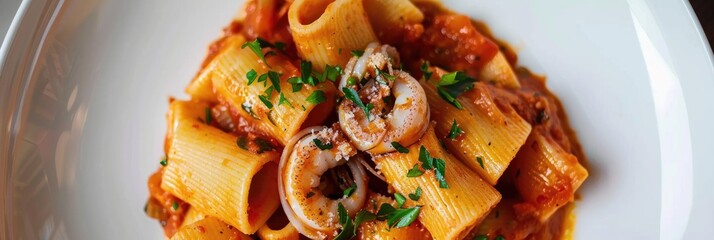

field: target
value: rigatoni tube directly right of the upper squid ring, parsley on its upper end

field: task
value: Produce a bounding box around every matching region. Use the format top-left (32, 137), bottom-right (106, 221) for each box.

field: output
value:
top-left (422, 71), bottom-right (531, 185)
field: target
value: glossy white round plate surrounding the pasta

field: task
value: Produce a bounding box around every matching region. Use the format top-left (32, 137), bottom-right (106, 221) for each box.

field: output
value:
top-left (0, 0), bottom-right (714, 239)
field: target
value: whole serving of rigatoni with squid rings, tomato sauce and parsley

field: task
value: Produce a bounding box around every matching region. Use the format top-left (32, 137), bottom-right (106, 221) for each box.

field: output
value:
top-left (144, 0), bottom-right (588, 240)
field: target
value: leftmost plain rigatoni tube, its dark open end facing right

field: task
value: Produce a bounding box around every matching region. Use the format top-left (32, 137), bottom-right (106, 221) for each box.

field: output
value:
top-left (161, 101), bottom-right (279, 234)
